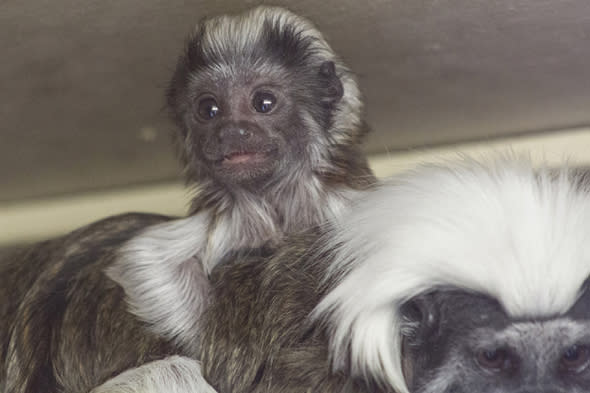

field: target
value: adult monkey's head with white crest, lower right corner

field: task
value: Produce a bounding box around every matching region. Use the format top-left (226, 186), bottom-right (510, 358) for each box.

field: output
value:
top-left (313, 160), bottom-right (590, 393)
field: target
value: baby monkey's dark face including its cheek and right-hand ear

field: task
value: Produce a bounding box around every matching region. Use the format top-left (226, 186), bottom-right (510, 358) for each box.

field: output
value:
top-left (173, 61), bottom-right (342, 185)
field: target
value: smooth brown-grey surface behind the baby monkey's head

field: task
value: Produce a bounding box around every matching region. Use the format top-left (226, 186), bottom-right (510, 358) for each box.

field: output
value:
top-left (0, 0), bottom-right (590, 242)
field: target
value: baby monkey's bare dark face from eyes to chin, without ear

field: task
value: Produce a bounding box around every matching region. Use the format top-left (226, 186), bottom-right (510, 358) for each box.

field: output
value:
top-left (191, 81), bottom-right (290, 184)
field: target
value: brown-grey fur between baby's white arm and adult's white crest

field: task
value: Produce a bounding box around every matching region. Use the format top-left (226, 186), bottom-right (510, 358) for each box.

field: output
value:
top-left (200, 232), bottom-right (388, 393)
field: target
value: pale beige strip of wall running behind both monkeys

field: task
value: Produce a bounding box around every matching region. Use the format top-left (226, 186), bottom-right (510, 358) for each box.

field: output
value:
top-left (0, 129), bottom-right (590, 247)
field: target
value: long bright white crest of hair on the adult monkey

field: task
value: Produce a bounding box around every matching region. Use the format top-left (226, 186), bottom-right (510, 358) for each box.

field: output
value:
top-left (313, 157), bottom-right (590, 393)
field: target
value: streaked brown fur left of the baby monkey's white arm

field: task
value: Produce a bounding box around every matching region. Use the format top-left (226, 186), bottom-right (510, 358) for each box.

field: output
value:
top-left (0, 214), bottom-right (177, 393)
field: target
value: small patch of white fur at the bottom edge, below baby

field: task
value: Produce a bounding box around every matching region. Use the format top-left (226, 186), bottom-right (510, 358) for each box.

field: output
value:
top-left (90, 356), bottom-right (216, 393)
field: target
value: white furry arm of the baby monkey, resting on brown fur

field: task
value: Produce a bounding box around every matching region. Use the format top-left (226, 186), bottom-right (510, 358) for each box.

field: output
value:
top-left (107, 211), bottom-right (210, 344)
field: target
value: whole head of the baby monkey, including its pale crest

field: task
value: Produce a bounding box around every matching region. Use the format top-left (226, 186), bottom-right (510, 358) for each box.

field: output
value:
top-left (168, 7), bottom-right (363, 188)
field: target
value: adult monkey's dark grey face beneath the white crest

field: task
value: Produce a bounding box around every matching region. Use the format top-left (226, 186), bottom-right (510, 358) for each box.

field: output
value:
top-left (403, 291), bottom-right (590, 393)
